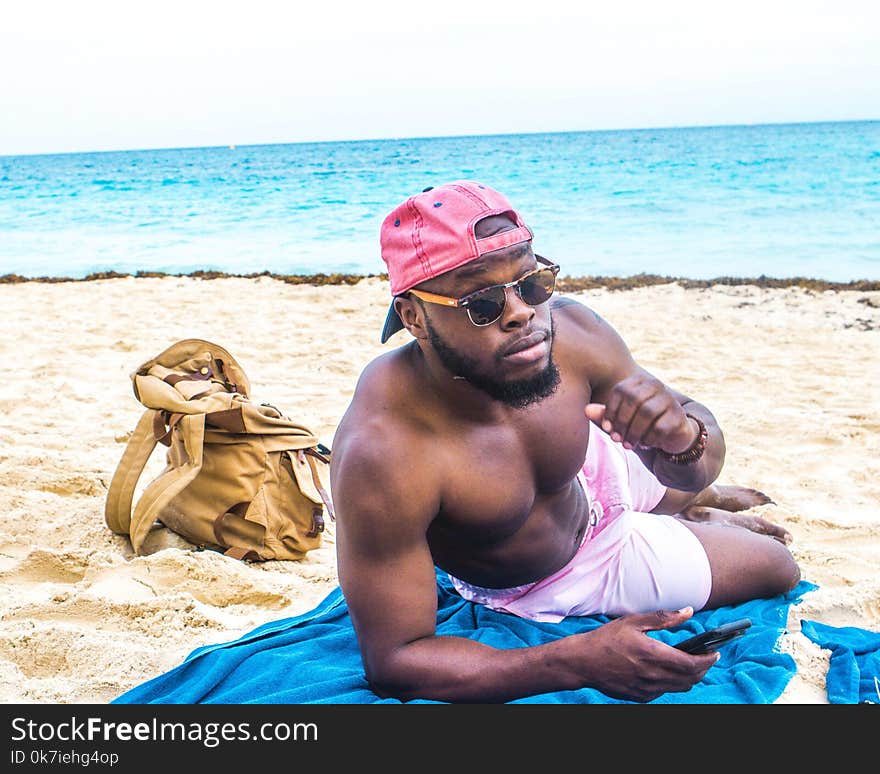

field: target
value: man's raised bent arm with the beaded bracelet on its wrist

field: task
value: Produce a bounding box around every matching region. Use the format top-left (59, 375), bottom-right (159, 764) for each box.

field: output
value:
top-left (554, 299), bottom-right (726, 492)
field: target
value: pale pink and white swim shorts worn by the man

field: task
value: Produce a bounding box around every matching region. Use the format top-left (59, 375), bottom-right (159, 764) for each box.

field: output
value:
top-left (449, 425), bottom-right (712, 623)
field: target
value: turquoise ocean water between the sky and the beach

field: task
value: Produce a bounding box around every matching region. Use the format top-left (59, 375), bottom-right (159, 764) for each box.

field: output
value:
top-left (0, 121), bottom-right (880, 282)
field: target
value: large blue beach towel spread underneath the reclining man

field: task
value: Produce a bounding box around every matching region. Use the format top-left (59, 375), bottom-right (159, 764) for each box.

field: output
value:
top-left (111, 571), bottom-right (816, 704)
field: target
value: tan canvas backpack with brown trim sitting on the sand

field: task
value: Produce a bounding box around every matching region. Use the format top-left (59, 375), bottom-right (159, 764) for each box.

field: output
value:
top-left (104, 339), bottom-right (333, 561)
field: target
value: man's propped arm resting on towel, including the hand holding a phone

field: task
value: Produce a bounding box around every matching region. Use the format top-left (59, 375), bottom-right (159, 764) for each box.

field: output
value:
top-left (331, 421), bottom-right (715, 702)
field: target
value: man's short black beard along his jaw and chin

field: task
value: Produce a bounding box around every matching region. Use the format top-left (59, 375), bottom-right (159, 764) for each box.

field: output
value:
top-left (425, 319), bottom-right (560, 409)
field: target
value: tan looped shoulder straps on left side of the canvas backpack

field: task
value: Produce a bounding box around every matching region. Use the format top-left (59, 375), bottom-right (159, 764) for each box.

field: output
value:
top-left (104, 409), bottom-right (205, 554)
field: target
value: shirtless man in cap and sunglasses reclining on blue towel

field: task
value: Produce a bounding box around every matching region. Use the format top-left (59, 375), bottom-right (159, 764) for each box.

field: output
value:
top-left (330, 181), bottom-right (800, 702)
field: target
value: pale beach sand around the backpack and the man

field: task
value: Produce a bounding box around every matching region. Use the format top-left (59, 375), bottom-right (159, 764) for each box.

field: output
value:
top-left (0, 278), bottom-right (880, 704)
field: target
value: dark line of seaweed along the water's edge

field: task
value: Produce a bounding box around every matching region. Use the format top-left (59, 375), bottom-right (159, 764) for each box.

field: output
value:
top-left (0, 270), bottom-right (880, 293)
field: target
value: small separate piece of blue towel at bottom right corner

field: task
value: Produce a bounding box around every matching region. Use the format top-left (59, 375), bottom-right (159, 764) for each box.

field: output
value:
top-left (801, 621), bottom-right (880, 704)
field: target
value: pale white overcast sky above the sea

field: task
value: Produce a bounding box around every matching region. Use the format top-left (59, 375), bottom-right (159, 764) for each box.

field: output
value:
top-left (0, 0), bottom-right (880, 154)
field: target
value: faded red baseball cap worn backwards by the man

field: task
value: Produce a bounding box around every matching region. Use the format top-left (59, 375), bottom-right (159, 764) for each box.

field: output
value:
top-left (379, 180), bottom-right (532, 344)
